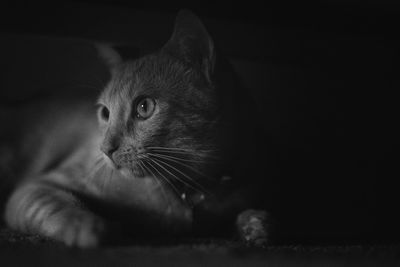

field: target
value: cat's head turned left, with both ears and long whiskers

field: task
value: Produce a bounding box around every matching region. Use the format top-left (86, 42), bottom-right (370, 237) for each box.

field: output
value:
top-left (98, 11), bottom-right (228, 186)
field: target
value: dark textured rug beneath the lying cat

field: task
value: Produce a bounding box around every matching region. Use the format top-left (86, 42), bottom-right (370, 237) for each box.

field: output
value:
top-left (0, 229), bottom-right (400, 266)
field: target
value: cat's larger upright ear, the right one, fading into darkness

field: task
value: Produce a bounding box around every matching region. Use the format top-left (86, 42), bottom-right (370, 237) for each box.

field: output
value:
top-left (163, 9), bottom-right (216, 80)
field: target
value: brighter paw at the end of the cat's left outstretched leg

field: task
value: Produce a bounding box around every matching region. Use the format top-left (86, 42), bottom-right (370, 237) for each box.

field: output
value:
top-left (44, 210), bottom-right (105, 248)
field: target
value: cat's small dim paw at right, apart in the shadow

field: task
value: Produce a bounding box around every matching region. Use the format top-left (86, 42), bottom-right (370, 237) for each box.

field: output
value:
top-left (236, 209), bottom-right (272, 247)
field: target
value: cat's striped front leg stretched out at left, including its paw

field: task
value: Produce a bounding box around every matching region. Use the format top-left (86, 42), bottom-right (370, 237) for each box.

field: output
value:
top-left (5, 176), bottom-right (105, 248)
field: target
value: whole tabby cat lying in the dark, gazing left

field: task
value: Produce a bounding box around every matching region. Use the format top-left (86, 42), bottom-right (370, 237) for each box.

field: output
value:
top-left (0, 10), bottom-right (271, 248)
